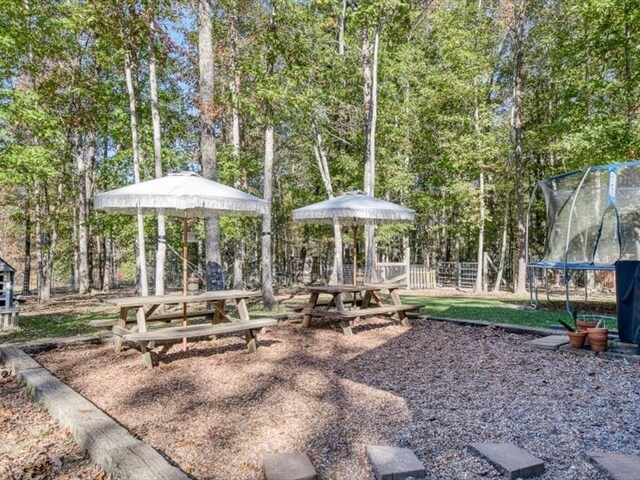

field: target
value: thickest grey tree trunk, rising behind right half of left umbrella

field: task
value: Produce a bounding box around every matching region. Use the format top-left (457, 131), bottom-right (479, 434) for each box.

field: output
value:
top-left (198, 0), bottom-right (224, 290)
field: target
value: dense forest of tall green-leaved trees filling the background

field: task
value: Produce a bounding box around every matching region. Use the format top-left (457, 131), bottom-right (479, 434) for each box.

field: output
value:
top-left (0, 0), bottom-right (640, 301)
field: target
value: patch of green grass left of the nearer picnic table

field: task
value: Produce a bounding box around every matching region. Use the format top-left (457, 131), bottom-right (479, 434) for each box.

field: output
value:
top-left (0, 313), bottom-right (105, 343)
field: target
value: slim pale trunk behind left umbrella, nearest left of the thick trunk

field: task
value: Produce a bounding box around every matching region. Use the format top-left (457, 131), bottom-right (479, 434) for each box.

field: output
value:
top-left (148, 6), bottom-right (167, 295)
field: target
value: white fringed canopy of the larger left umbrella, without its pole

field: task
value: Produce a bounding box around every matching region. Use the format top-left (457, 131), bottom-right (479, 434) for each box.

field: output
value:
top-left (93, 172), bottom-right (267, 218)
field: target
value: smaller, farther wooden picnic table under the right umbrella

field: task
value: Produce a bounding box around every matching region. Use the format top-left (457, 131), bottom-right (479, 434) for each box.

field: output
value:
top-left (302, 283), bottom-right (419, 335)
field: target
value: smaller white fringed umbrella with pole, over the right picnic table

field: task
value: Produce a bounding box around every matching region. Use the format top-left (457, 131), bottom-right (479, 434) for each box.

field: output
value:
top-left (293, 190), bottom-right (416, 285)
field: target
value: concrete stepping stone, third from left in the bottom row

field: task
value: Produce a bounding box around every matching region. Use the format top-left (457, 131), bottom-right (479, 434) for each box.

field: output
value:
top-left (467, 443), bottom-right (544, 480)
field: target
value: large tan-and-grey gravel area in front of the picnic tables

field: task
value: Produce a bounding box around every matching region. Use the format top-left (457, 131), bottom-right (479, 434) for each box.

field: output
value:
top-left (37, 319), bottom-right (640, 480)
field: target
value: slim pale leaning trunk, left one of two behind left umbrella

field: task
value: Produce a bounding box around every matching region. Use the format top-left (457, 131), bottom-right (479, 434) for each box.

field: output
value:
top-left (124, 48), bottom-right (149, 297)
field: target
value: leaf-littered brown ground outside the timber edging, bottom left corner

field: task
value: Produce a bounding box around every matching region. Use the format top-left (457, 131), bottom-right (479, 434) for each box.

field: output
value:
top-left (0, 366), bottom-right (106, 480)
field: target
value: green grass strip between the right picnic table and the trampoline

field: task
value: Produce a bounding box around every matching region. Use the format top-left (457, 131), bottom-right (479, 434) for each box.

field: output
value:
top-left (402, 295), bottom-right (617, 328)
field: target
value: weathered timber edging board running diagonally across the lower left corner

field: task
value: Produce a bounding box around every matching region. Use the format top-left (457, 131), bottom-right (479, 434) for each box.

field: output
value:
top-left (0, 347), bottom-right (192, 480)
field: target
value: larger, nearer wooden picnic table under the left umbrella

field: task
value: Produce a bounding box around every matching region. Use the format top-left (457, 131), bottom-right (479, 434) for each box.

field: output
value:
top-left (104, 290), bottom-right (276, 368)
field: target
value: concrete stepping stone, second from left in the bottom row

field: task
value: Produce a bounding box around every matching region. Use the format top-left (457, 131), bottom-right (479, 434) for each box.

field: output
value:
top-left (366, 445), bottom-right (427, 480)
